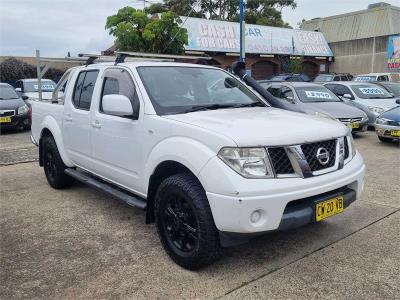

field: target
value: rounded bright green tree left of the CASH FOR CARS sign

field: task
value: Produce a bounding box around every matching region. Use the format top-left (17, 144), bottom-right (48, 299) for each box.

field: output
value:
top-left (105, 5), bottom-right (188, 54)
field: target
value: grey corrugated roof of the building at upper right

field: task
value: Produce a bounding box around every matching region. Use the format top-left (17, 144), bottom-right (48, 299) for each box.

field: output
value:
top-left (302, 5), bottom-right (400, 43)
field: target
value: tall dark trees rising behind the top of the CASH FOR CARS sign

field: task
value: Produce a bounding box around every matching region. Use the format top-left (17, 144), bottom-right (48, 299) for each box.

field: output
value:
top-left (148, 0), bottom-right (297, 27)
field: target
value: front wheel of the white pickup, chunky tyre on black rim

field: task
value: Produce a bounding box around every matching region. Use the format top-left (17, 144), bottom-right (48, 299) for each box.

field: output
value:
top-left (154, 173), bottom-right (221, 270)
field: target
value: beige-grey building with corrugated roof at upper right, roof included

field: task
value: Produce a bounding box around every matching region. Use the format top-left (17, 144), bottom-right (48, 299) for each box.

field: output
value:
top-left (302, 3), bottom-right (400, 75)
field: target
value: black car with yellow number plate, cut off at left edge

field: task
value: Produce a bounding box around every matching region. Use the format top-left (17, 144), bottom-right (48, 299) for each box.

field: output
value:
top-left (0, 83), bottom-right (31, 130)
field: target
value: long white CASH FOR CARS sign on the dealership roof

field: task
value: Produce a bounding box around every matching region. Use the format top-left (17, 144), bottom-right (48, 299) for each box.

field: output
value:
top-left (181, 17), bottom-right (333, 57)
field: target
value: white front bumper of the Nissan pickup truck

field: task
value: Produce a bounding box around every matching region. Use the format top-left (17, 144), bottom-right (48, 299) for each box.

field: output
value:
top-left (199, 152), bottom-right (365, 234)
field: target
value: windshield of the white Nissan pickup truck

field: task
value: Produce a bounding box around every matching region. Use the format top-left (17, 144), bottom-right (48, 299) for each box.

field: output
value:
top-left (137, 66), bottom-right (266, 115)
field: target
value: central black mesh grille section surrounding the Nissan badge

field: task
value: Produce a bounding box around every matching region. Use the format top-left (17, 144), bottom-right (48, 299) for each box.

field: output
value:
top-left (301, 140), bottom-right (336, 172)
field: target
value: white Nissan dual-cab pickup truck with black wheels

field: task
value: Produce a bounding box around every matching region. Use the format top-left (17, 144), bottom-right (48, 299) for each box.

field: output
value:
top-left (32, 62), bottom-right (365, 269)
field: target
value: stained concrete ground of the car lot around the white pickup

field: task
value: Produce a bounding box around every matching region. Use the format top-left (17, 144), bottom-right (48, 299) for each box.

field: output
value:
top-left (0, 132), bottom-right (400, 299)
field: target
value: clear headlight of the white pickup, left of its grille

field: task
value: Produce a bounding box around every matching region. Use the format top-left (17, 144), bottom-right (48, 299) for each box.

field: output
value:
top-left (218, 148), bottom-right (274, 178)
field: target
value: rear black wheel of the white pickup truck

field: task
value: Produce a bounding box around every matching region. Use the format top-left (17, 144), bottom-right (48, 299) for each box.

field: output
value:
top-left (43, 136), bottom-right (74, 189)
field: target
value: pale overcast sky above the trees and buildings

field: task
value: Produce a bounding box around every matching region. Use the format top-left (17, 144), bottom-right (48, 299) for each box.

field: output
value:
top-left (0, 0), bottom-right (400, 57)
